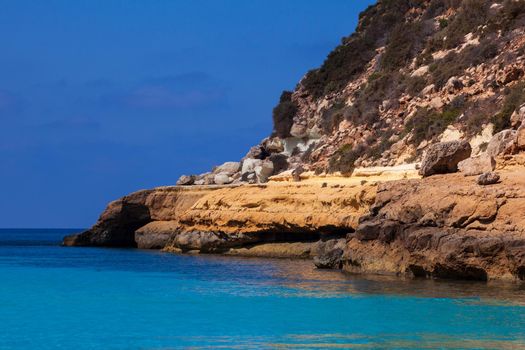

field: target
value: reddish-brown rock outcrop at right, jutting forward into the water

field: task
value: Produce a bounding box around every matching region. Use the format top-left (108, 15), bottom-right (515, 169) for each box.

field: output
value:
top-left (343, 159), bottom-right (525, 280)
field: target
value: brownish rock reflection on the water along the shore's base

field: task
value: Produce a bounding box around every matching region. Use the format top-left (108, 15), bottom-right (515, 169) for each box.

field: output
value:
top-left (188, 255), bottom-right (525, 305)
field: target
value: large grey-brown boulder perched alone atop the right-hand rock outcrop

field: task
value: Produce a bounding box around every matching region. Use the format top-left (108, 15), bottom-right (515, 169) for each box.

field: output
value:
top-left (419, 141), bottom-right (472, 177)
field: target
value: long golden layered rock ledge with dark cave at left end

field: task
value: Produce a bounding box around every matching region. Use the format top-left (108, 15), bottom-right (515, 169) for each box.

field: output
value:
top-left (64, 179), bottom-right (375, 253)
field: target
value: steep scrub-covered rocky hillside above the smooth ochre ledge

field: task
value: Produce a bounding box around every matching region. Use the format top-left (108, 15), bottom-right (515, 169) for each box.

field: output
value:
top-left (179, 0), bottom-right (525, 185)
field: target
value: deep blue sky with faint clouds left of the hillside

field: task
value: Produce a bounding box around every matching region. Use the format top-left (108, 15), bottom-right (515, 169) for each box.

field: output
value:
top-left (0, 0), bottom-right (374, 228)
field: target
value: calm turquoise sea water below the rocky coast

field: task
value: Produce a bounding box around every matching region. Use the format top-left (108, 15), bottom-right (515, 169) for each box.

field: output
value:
top-left (0, 230), bottom-right (525, 349)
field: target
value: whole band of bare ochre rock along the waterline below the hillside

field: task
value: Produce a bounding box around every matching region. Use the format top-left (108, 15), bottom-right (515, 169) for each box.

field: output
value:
top-left (64, 150), bottom-right (525, 281)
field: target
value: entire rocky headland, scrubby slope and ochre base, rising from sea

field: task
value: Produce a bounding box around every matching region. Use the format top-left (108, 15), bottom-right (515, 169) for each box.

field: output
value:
top-left (64, 0), bottom-right (525, 280)
